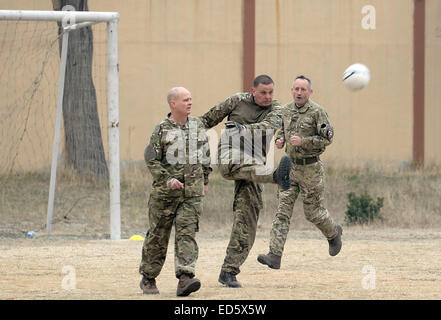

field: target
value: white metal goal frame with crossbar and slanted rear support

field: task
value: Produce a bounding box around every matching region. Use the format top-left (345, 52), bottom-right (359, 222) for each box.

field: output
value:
top-left (0, 8), bottom-right (121, 240)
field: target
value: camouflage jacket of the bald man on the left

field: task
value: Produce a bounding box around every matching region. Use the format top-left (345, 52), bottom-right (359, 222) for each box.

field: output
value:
top-left (144, 117), bottom-right (211, 197)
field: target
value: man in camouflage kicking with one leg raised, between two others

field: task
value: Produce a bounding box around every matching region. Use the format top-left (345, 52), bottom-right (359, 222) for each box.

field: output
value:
top-left (201, 75), bottom-right (291, 288)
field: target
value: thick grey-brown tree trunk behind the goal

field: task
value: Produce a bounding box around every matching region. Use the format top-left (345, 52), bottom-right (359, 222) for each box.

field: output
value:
top-left (52, 0), bottom-right (109, 180)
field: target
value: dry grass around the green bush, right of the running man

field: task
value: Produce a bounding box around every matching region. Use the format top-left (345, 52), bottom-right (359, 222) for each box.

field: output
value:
top-left (327, 165), bottom-right (441, 228)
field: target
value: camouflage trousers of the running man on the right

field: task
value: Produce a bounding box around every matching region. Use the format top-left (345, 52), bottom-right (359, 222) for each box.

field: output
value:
top-left (269, 161), bottom-right (337, 256)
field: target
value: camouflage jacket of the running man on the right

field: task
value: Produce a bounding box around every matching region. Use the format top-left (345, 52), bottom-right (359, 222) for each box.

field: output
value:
top-left (246, 100), bottom-right (334, 159)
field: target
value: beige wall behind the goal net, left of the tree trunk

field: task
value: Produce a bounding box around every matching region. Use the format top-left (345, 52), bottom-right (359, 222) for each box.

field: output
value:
top-left (0, 1), bottom-right (59, 174)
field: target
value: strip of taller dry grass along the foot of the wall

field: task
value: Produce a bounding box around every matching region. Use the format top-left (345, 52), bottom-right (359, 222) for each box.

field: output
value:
top-left (0, 164), bottom-right (441, 238)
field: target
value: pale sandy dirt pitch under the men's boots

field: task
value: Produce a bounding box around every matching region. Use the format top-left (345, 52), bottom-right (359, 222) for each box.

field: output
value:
top-left (0, 227), bottom-right (441, 300)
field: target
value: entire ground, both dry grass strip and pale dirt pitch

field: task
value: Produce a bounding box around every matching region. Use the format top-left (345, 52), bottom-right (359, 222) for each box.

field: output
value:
top-left (0, 165), bottom-right (441, 300)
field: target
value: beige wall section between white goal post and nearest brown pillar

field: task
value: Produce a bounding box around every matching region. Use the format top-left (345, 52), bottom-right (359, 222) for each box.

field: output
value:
top-left (89, 0), bottom-right (242, 160)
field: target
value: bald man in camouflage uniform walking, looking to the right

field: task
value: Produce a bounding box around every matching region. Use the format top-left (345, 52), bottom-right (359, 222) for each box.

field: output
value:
top-left (139, 87), bottom-right (211, 296)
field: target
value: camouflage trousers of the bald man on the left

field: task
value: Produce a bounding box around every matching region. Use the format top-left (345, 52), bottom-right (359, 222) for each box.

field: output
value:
top-left (139, 197), bottom-right (202, 278)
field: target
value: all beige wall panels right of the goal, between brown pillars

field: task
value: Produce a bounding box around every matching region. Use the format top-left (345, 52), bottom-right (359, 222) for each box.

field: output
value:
top-left (0, 0), bottom-right (441, 167)
